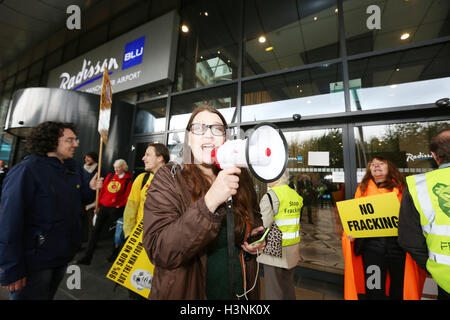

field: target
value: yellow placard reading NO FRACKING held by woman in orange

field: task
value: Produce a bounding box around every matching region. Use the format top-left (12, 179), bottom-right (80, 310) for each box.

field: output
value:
top-left (336, 192), bottom-right (400, 238)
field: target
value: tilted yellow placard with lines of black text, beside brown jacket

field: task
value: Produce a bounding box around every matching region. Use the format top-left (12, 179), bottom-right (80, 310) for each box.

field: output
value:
top-left (106, 219), bottom-right (155, 298)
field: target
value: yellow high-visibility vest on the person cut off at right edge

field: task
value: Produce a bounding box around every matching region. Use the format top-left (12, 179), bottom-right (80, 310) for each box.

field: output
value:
top-left (406, 167), bottom-right (450, 292)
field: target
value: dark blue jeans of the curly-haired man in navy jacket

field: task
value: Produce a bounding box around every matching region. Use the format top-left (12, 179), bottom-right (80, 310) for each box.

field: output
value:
top-left (9, 265), bottom-right (67, 300)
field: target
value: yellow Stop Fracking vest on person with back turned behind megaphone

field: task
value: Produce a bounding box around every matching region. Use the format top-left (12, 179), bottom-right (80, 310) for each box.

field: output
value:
top-left (271, 184), bottom-right (303, 247)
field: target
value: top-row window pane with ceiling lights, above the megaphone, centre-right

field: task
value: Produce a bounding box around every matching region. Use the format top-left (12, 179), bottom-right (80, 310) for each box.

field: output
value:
top-left (244, 0), bottom-right (339, 76)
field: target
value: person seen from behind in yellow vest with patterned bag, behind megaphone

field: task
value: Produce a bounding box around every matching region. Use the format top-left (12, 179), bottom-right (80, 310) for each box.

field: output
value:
top-left (257, 170), bottom-right (303, 300)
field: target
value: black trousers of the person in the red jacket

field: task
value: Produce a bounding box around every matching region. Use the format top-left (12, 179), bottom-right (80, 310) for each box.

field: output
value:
top-left (84, 206), bottom-right (124, 260)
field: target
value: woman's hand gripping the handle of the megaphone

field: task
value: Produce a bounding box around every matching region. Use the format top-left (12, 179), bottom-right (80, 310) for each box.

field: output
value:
top-left (205, 167), bottom-right (241, 212)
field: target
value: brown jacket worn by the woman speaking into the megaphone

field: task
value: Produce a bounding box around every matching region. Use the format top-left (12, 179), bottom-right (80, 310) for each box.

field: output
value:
top-left (142, 162), bottom-right (262, 300)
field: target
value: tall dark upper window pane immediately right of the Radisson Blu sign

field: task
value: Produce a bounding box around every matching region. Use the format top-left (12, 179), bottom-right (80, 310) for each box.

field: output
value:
top-left (175, 0), bottom-right (240, 91)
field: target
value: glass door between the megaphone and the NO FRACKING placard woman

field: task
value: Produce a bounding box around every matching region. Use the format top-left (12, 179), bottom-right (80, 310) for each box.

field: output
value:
top-left (284, 128), bottom-right (345, 274)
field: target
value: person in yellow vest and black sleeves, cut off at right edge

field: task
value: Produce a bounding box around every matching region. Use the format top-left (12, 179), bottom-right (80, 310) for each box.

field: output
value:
top-left (398, 129), bottom-right (450, 300)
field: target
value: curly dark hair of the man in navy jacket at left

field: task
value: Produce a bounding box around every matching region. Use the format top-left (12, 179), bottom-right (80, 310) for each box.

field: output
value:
top-left (26, 121), bottom-right (77, 157)
